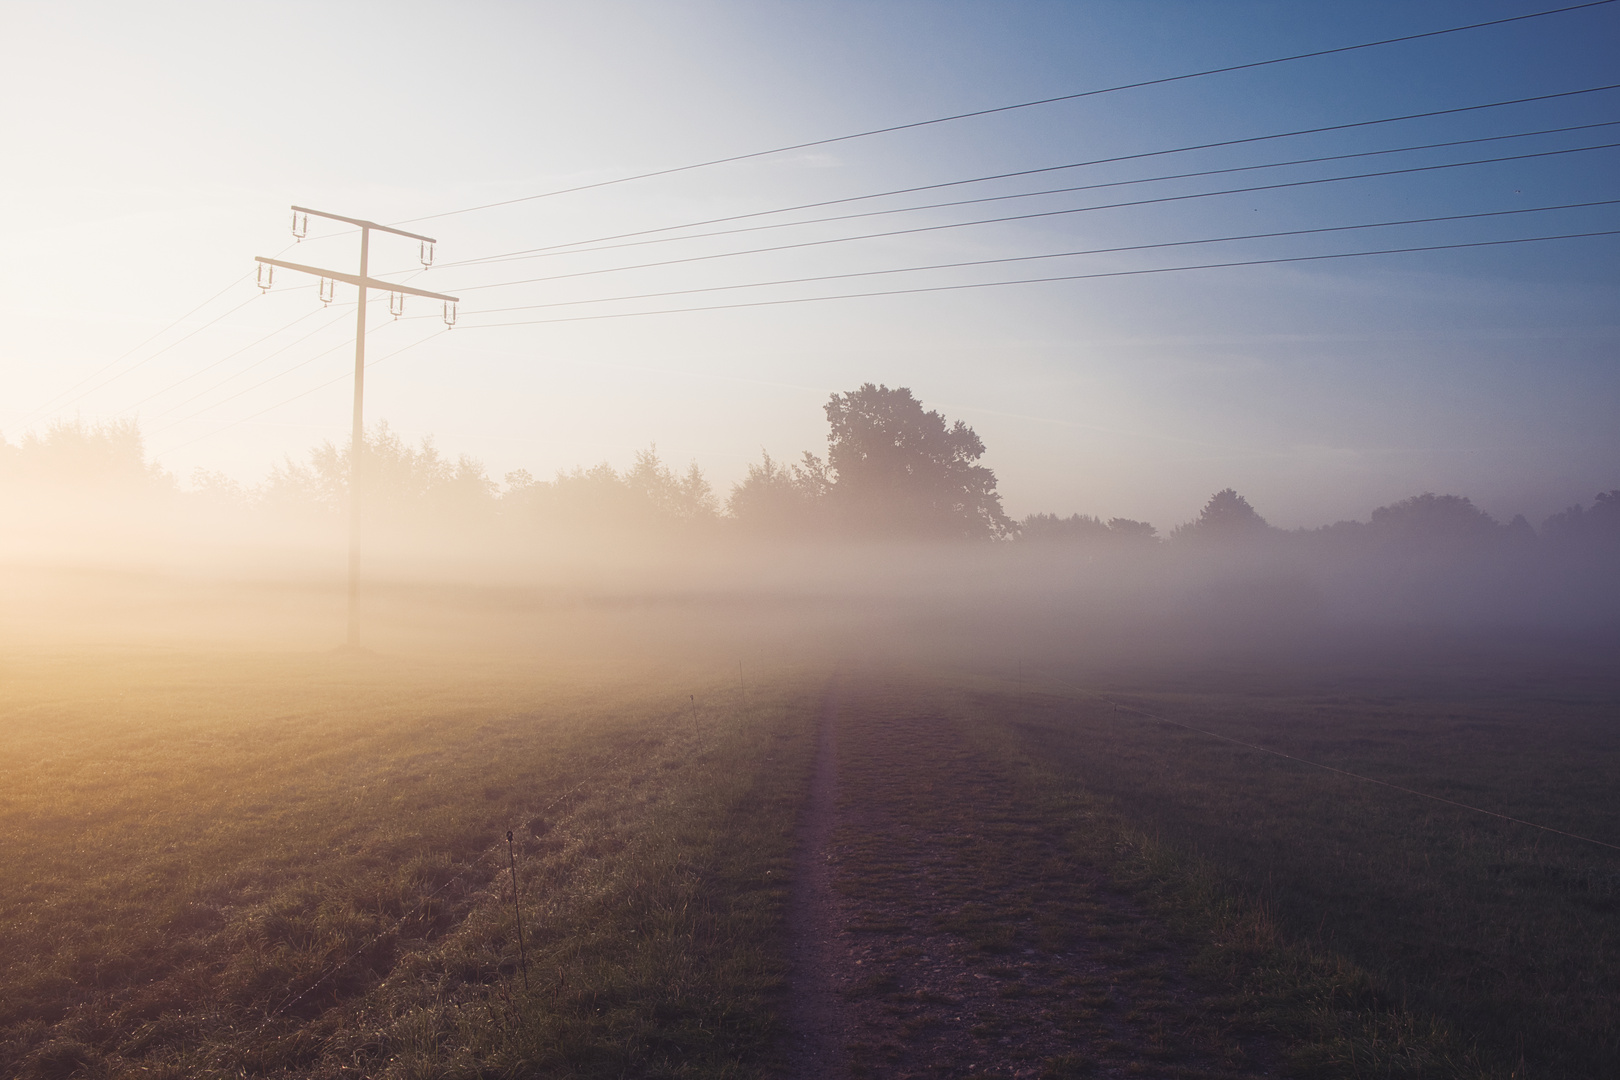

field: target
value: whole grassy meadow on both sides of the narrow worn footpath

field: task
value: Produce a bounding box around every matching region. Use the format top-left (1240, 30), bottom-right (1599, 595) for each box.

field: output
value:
top-left (0, 634), bottom-right (1620, 1080)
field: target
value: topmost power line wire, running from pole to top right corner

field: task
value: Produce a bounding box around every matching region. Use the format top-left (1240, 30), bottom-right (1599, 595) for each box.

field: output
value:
top-left (395, 0), bottom-right (1615, 225)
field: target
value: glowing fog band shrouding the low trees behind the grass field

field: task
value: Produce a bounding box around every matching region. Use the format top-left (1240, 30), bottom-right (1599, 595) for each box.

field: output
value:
top-left (0, 414), bottom-right (1620, 670)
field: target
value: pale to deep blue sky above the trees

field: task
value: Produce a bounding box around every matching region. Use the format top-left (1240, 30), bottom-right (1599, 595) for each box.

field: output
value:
top-left (0, 0), bottom-right (1620, 531)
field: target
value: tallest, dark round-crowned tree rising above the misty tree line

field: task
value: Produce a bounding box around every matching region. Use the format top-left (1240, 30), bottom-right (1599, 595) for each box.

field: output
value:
top-left (826, 382), bottom-right (1013, 539)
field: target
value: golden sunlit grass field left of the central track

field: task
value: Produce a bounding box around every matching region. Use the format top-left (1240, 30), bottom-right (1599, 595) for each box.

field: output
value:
top-left (0, 654), bottom-right (813, 1077)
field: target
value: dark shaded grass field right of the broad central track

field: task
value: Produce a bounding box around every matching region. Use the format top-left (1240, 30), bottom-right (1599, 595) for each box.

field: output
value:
top-left (977, 650), bottom-right (1620, 1077)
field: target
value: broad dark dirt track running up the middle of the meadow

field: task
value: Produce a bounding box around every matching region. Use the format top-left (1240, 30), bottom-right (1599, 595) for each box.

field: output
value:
top-left (791, 680), bottom-right (1272, 1078)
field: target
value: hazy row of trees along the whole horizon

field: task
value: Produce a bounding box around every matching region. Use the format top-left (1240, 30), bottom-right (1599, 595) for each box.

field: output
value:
top-left (0, 382), bottom-right (1620, 552)
